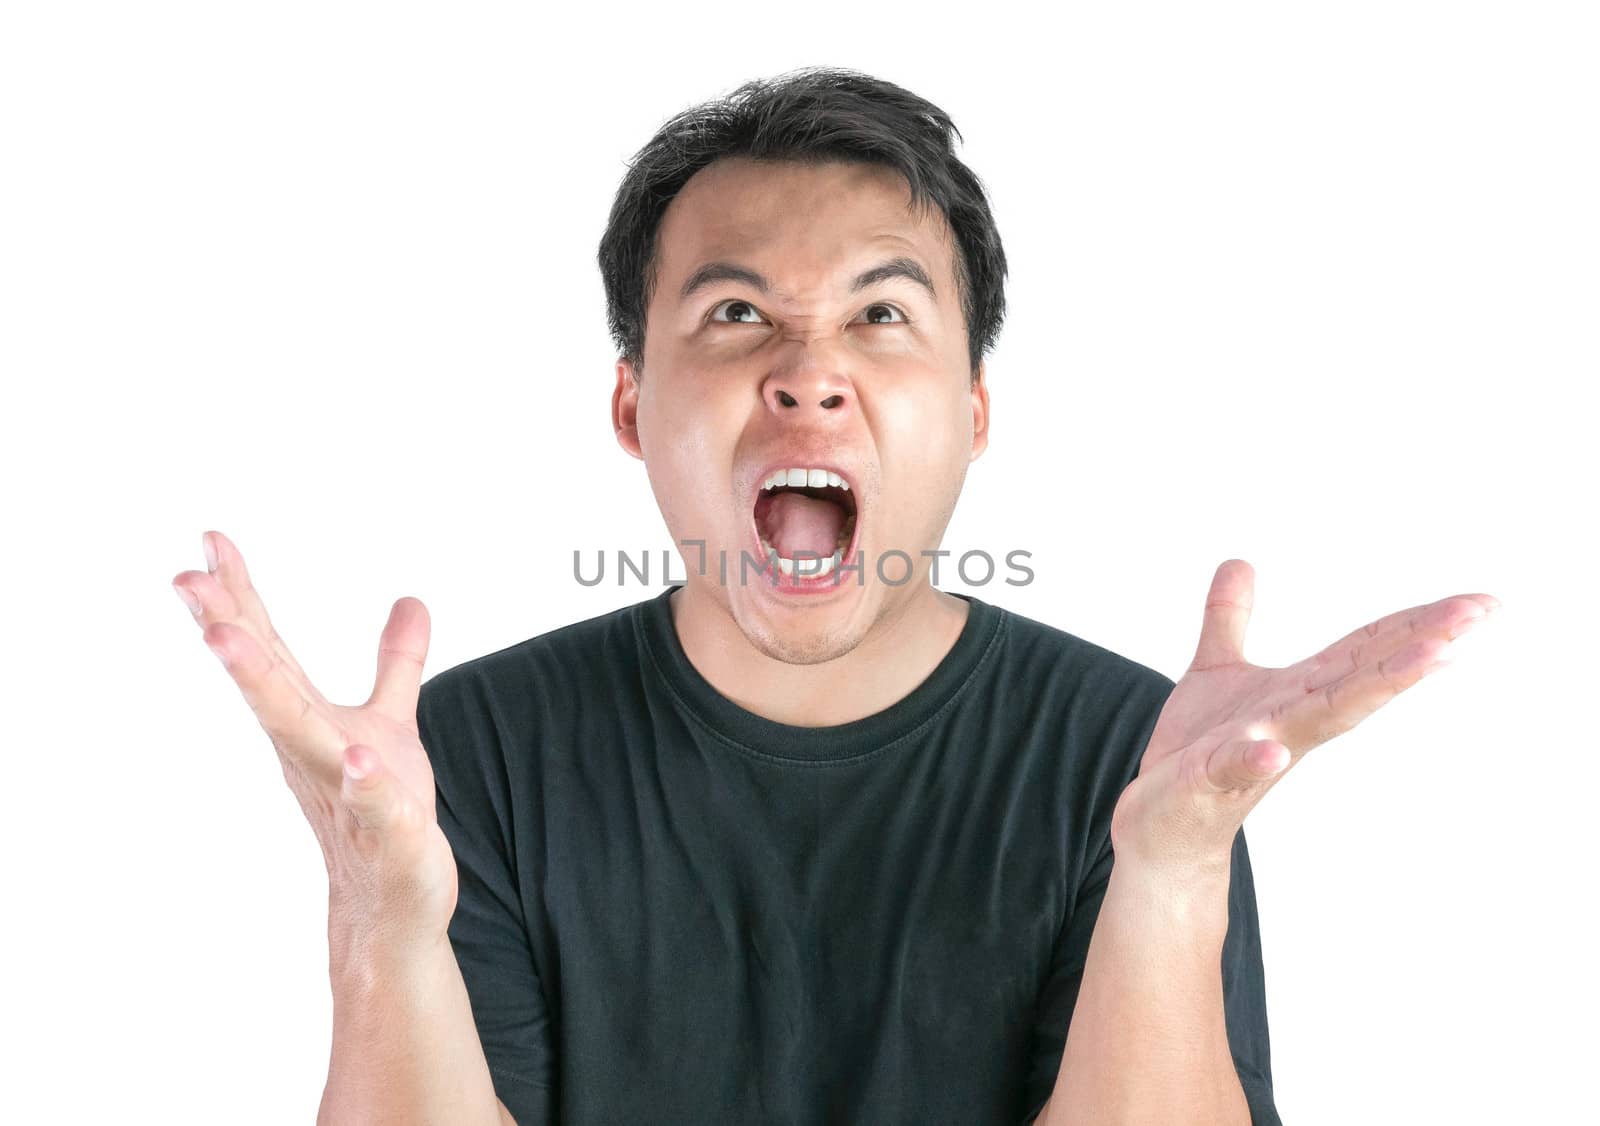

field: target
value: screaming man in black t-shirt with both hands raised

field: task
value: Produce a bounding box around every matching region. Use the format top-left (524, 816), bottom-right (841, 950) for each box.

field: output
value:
top-left (174, 69), bottom-right (1496, 1126)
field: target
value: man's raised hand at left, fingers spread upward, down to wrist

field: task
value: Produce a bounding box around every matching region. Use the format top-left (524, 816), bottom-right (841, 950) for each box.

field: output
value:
top-left (173, 531), bottom-right (456, 948)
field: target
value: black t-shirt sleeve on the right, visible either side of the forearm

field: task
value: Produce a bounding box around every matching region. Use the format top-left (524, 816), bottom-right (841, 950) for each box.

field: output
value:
top-left (1022, 829), bottom-right (1282, 1126)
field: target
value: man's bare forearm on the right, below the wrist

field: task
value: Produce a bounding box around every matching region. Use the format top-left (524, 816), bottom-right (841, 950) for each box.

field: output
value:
top-left (1038, 860), bottom-right (1250, 1126)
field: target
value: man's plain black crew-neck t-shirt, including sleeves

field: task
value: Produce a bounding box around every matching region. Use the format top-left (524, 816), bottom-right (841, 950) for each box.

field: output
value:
top-left (418, 587), bottom-right (1278, 1126)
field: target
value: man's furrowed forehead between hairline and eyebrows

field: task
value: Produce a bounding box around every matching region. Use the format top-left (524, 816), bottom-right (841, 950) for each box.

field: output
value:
top-left (658, 157), bottom-right (955, 302)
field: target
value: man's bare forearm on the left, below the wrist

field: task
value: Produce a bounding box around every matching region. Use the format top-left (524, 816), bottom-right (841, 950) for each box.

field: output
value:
top-left (317, 908), bottom-right (515, 1126)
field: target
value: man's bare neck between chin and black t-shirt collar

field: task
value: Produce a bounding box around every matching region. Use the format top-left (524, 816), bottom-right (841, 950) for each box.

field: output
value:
top-left (669, 581), bottom-right (970, 728)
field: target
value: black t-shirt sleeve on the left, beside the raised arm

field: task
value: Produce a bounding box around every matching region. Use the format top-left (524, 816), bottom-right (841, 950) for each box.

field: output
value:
top-left (418, 678), bottom-right (555, 1126)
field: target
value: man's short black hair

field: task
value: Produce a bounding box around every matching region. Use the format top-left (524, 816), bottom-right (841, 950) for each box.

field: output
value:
top-left (598, 67), bottom-right (1006, 379)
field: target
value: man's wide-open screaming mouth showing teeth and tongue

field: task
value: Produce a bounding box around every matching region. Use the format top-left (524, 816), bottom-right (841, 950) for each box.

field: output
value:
top-left (755, 469), bottom-right (856, 579)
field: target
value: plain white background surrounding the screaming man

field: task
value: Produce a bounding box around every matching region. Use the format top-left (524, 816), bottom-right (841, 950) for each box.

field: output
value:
top-left (0, 0), bottom-right (1600, 1126)
